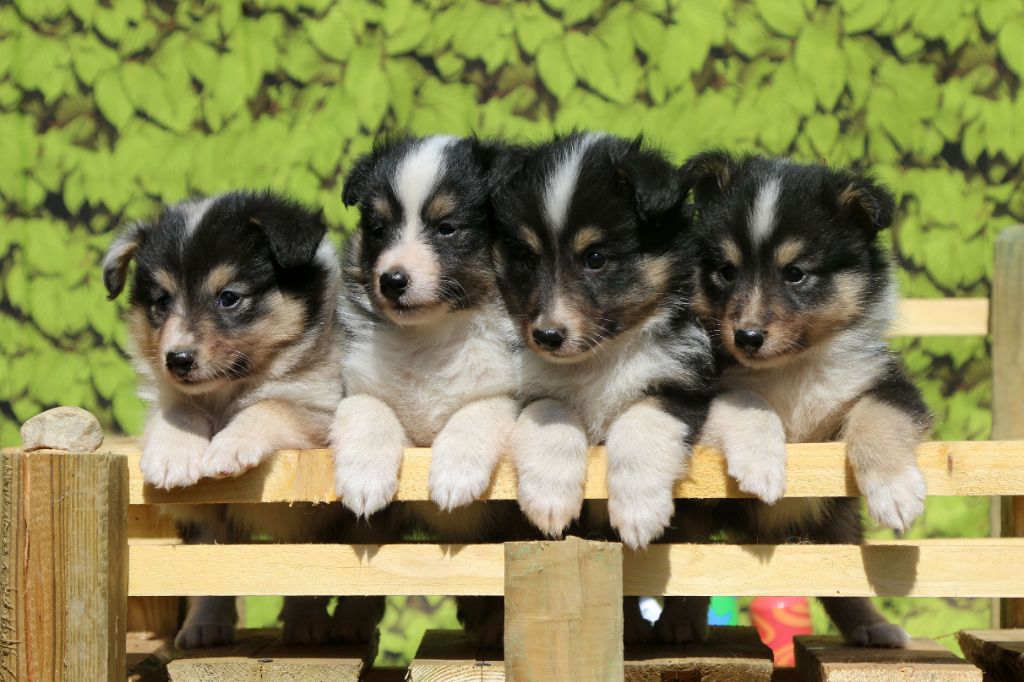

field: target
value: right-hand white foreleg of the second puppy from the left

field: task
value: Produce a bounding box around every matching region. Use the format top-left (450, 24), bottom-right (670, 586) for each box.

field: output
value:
top-left (429, 397), bottom-right (517, 511)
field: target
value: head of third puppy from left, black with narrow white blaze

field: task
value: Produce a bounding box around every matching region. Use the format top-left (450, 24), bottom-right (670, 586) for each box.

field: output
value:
top-left (493, 133), bottom-right (689, 363)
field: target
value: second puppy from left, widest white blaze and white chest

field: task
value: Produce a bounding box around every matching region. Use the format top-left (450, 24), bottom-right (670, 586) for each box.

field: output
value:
top-left (331, 136), bottom-right (518, 644)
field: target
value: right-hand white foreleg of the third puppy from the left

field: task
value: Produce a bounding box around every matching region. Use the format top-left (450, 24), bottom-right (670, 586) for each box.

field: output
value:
top-left (607, 400), bottom-right (689, 549)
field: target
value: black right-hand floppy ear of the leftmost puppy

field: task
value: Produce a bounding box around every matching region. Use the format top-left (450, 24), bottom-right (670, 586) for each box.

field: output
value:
top-left (249, 197), bottom-right (327, 269)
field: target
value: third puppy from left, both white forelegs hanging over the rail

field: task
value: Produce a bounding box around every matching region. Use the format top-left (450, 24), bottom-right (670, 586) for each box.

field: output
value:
top-left (493, 133), bottom-right (713, 548)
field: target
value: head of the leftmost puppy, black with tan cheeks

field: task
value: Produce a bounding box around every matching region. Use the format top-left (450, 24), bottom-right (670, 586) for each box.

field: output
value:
top-left (102, 193), bottom-right (329, 394)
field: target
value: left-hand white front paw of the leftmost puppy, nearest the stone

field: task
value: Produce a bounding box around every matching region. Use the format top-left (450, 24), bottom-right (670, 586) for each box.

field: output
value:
top-left (139, 404), bottom-right (212, 489)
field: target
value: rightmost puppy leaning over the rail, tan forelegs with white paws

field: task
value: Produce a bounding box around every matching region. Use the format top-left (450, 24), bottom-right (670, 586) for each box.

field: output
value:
top-left (683, 152), bottom-right (931, 647)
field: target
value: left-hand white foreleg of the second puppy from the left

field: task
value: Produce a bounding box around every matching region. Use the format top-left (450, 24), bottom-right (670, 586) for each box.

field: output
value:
top-left (331, 395), bottom-right (409, 516)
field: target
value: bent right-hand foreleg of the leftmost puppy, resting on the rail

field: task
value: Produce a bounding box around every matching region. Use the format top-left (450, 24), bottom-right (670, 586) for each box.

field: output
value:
top-left (201, 400), bottom-right (324, 478)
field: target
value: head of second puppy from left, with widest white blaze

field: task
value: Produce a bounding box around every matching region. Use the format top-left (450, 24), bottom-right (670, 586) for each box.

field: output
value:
top-left (342, 136), bottom-right (494, 326)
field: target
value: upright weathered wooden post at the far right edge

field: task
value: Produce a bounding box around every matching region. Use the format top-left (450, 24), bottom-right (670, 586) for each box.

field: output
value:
top-left (992, 226), bottom-right (1024, 628)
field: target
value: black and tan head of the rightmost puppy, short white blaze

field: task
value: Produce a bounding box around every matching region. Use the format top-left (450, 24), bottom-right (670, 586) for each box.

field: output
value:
top-left (681, 152), bottom-right (895, 368)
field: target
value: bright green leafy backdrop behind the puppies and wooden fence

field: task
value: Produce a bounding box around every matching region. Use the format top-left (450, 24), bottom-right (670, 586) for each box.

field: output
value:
top-left (0, 0), bottom-right (1024, 660)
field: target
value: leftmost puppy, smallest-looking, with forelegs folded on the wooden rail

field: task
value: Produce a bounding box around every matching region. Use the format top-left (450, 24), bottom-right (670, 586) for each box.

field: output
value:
top-left (102, 191), bottom-right (379, 648)
